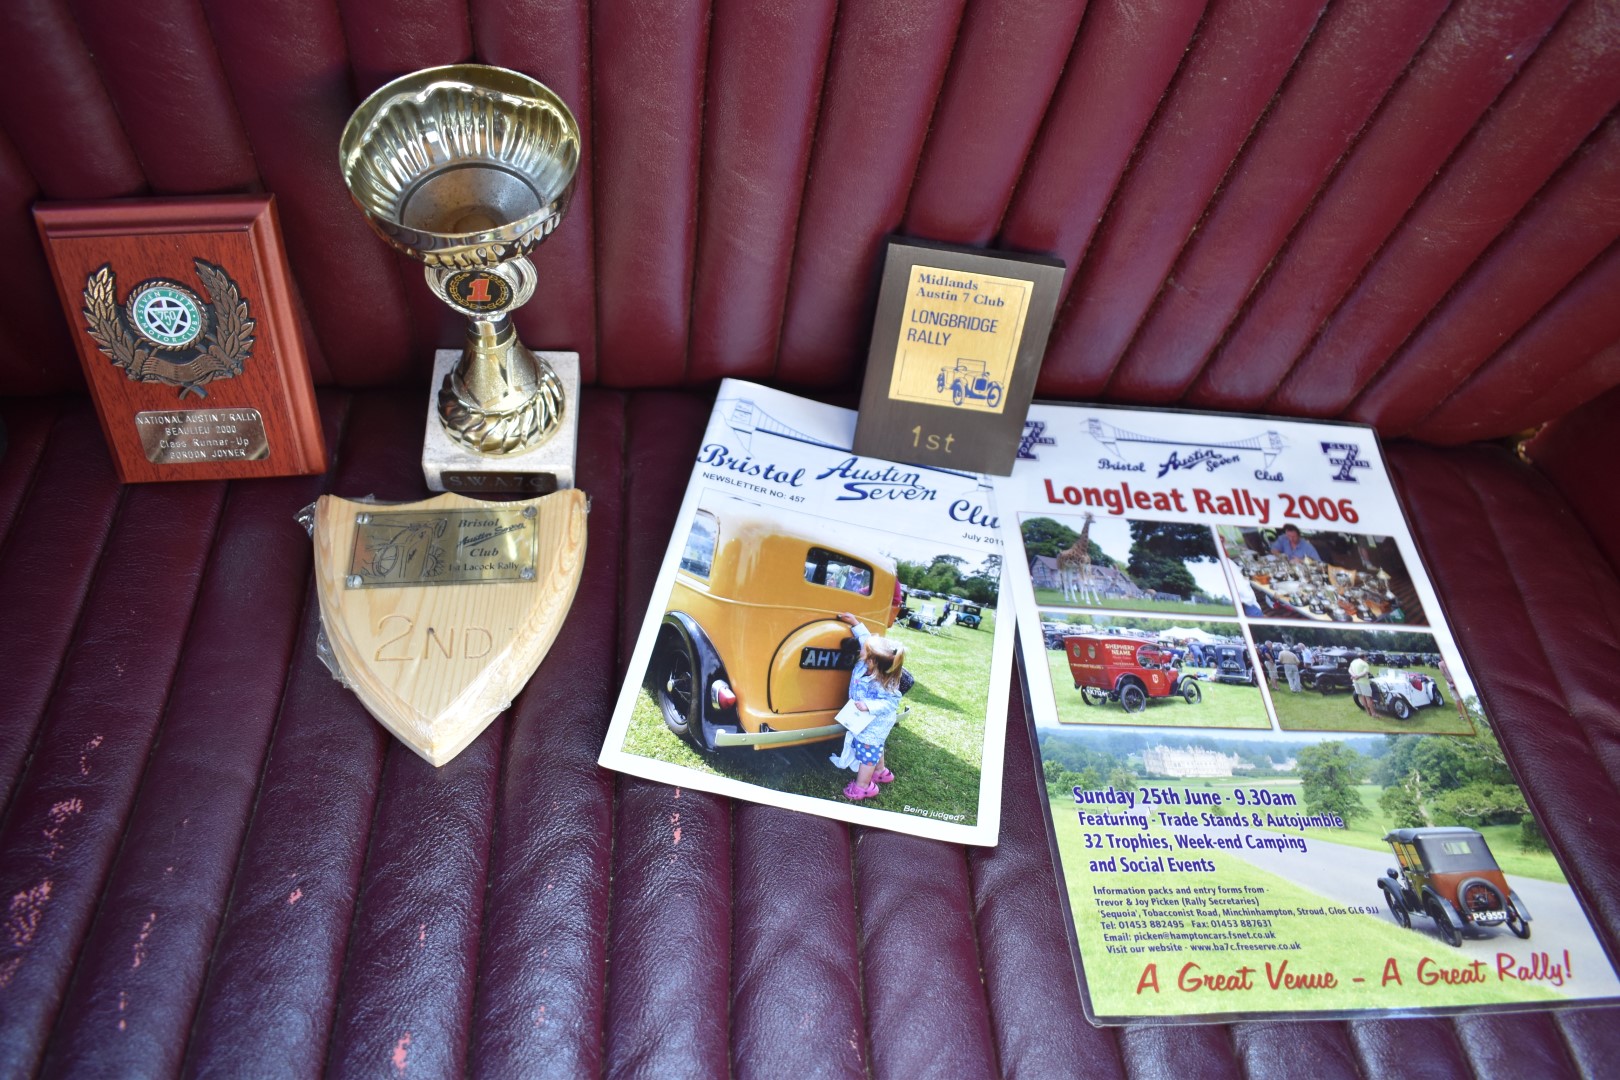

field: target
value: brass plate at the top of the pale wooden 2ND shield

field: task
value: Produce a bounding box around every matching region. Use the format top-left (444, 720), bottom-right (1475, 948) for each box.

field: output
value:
top-left (347, 507), bottom-right (538, 589)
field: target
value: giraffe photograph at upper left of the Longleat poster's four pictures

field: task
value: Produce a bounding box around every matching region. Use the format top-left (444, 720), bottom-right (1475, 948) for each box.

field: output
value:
top-left (1019, 512), bottom-right (1238, 617)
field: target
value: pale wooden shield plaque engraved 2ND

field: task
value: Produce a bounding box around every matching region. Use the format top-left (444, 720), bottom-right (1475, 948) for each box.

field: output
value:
top-left (314, 491), bottom-right (585, 766)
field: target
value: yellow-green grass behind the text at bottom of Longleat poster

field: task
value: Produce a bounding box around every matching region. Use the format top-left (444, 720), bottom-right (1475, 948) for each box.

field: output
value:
top-left (1051, 800), bottom-right (1560, 1017)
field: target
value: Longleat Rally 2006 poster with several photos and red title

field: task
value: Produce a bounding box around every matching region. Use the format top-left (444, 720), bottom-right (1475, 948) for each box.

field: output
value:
top-left (996, 405), bottom-right (1620, 1023)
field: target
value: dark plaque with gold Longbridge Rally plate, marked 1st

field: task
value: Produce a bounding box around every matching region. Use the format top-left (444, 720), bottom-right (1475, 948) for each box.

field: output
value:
top-left (854, 240), bottom-right (1063, 476)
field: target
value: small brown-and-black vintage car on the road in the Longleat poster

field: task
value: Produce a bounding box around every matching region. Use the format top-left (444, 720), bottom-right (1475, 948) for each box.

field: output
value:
top-left (1379, 826), bottom-right (1531, 946)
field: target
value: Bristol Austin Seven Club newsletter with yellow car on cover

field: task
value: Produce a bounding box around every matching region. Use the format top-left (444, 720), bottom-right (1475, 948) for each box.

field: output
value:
top-left (601, 379), bottom-right (1014, 844)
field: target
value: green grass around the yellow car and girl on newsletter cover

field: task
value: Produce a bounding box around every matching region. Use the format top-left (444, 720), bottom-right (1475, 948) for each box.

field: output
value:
top-left (624, 609), bottom-right (995, 824)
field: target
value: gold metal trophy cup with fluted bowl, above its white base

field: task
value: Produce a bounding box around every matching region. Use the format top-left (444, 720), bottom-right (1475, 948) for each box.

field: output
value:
top-left (339, 63), bottom-right (580, 453)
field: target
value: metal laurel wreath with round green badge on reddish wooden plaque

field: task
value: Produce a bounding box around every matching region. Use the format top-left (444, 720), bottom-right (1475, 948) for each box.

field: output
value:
top-left (84, 259), bottom-right (258, 398)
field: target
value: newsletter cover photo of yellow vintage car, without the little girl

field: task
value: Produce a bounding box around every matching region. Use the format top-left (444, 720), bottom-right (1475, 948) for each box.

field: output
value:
top-left (624, 497), bottom-right (1000, 823)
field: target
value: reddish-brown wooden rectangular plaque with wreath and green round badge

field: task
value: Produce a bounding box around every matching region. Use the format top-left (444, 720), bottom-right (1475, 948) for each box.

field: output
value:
top-left (34, 194), bottom-right (326, 484)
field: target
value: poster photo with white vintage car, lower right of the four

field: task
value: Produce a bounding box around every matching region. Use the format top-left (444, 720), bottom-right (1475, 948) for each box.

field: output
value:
top-left (1251, 623), bottom-right (1474, 735)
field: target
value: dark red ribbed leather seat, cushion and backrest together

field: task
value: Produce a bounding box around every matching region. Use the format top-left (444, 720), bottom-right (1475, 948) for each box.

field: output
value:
top-left (0, 0), bottom-right (1620, 1077)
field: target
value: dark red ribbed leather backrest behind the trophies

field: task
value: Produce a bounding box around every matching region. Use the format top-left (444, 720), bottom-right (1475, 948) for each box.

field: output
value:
top-left (0, 0), bottom-right (1620, 442)
